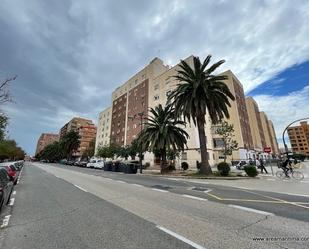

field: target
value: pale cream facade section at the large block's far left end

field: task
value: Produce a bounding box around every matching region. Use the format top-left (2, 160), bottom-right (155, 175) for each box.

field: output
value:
top-left (95, 106), bottom-right (112, 151)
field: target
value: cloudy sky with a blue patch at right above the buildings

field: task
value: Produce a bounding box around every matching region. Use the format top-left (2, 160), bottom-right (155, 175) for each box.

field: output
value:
top-left (0, 0), bottom-right (309, 154)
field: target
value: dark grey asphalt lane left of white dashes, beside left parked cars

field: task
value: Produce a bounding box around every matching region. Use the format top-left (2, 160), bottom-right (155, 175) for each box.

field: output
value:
top-left (0, 163), bottom-right (192, 249)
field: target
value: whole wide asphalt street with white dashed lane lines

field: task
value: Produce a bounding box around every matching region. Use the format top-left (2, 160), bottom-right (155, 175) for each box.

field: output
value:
top-left (0, 163), bottom-right (309, 249)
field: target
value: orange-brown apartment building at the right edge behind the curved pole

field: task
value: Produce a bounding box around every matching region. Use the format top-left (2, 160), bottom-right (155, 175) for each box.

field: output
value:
top-left (288, 121), bottom-right (309, 156)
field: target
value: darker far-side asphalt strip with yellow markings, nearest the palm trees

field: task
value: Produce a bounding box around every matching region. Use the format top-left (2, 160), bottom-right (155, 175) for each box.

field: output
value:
top-left (47, 164), bottom-right (309, 222)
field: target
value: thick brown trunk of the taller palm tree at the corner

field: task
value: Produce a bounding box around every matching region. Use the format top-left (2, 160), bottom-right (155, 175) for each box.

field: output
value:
top-left (197, 117), bottom-right (212, 175)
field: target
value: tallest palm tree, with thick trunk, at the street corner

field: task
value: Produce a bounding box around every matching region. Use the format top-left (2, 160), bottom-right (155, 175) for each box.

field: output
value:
top-left (169, 55), bottom-right (234, 175)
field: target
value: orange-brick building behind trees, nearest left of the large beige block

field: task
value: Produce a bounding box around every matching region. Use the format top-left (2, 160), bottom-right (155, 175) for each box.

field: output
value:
top-left (59, 117), bottom-right (97, 157)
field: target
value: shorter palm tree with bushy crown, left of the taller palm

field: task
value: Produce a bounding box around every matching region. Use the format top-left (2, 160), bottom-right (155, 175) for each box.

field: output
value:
top-left (138, 104), bottom-right (189, 173)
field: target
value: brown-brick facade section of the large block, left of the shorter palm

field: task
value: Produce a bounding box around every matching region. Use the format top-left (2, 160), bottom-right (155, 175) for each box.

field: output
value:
top-left (110, 58), bottom-right (168, 145)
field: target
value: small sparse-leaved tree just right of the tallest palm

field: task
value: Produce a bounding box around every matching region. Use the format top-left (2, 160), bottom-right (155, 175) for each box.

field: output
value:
top-left (216, 121), bottom-right (238, 162)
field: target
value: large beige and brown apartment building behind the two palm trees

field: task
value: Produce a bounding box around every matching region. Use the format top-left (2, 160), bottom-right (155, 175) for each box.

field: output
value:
top-left (96, 56), bottom-right (276, 166)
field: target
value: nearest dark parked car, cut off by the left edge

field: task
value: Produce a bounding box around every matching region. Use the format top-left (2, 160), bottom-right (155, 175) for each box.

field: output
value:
top-left (0, 168), bottom-right (13, 211)
